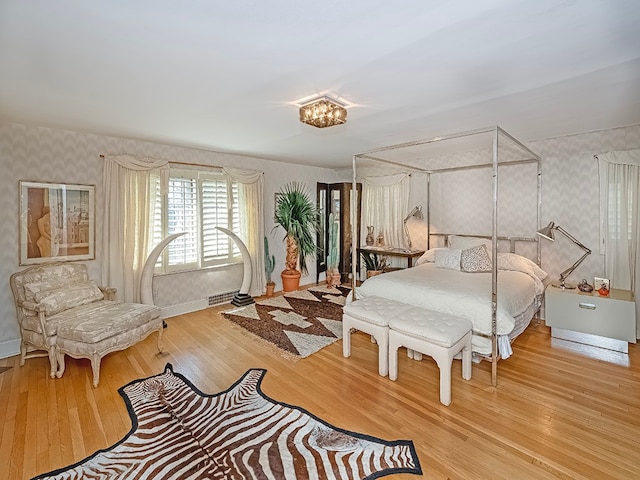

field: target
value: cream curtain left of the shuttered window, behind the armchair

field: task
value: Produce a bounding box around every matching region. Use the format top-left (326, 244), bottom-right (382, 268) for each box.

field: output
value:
top-left (102, 155), bottom-right (168, 302)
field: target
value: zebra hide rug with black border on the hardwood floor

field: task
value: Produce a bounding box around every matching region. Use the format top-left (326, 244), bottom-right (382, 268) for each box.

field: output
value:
top-left (35, 363), bottom-right (422, 480)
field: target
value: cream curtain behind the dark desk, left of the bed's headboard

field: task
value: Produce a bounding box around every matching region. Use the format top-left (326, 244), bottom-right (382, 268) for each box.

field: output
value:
top-left (360, 173), bottom-right (410, 248)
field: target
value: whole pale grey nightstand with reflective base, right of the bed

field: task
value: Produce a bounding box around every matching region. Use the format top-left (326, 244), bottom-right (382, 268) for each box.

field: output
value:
top-left (545, 286), bottom-right (636, 353)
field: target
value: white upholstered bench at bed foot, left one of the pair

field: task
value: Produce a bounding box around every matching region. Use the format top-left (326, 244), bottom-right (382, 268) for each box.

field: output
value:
top-left (342, 296), bottom-right (411, 377)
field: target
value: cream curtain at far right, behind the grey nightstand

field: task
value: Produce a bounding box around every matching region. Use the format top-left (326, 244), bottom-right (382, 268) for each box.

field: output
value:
top-left (595, 149), bottom-right (640, 338)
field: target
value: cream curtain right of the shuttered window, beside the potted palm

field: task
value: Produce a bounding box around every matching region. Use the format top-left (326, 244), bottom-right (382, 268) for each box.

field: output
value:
top-left (223, 167), bottom-right (267, 297)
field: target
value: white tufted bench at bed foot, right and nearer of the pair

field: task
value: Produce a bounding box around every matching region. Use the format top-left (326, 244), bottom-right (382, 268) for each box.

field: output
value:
top-left (389, 307), bottom-right (472, 405)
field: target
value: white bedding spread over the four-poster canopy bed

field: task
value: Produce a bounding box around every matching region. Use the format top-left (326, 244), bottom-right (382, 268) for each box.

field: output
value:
top-left (356, 263), bottom-right (544, 358)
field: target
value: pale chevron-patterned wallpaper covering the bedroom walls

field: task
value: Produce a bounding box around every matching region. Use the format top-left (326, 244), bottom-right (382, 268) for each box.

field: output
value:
top-left (0, 123), bottom-right (640, 357)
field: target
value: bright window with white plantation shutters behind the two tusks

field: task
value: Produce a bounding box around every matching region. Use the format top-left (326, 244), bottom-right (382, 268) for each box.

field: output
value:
top-left (152, 170), bottom-right (241, 272)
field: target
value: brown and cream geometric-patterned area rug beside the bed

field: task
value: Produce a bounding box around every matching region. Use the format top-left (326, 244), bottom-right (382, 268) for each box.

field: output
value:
top-left (222, 285), bottom-right (351, 358)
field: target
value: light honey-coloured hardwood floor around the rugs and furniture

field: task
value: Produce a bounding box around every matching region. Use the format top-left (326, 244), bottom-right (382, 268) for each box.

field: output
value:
top-left (0, 298), bottom-right (640, 480)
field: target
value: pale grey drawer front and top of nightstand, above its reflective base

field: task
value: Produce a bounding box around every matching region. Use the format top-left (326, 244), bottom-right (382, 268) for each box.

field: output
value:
top-left (545, 286), bottom-right (636, 343)
